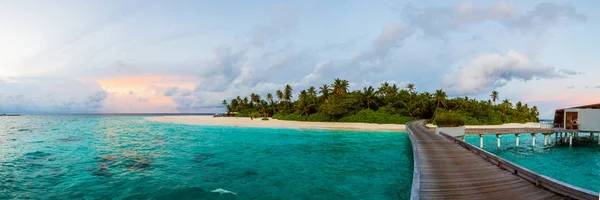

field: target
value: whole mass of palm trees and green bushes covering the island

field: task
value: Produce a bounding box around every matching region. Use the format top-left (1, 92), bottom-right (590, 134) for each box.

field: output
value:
top-left (222, 79), bottom-right (539, 125)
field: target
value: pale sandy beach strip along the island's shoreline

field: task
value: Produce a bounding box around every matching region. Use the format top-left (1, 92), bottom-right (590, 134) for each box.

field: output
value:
top-left (148, 116), bottom-right (539, 131)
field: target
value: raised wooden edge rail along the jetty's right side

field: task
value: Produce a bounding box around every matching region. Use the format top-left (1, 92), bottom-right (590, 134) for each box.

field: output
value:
top-left (436, 127), bottom-right (600, 200)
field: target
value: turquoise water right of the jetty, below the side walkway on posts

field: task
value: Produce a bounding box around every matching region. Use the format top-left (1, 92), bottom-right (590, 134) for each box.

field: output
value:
top-left (466, 133), bottom-right (600, 192)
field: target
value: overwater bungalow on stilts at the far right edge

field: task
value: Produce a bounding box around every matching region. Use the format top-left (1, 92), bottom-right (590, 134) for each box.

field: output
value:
top-left (553, 103), bottom-right (600, 132)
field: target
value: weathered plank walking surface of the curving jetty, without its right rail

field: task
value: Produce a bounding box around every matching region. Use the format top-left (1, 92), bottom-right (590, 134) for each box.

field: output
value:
top-left (407, 120), bottom-right (565, 199)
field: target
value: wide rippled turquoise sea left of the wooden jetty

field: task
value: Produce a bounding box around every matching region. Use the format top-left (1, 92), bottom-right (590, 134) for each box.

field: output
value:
top-left (0, 115), bottom-right (413, 199)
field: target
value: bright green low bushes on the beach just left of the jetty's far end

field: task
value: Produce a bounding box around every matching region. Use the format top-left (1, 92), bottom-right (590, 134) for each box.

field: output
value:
top-left (339, 109), bottom-right (415, 124)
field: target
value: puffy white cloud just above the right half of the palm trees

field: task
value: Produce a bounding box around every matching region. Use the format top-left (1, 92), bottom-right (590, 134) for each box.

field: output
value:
top-left (444, 50), bottom-right (577, 95)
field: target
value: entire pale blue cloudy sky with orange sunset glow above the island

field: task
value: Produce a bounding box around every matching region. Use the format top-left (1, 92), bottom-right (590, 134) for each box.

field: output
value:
top-left (0, 0), bottom-right (600, 118)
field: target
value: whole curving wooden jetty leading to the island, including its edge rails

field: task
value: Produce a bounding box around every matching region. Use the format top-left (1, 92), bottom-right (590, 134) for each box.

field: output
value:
top-left (406, 120), bottom-right (598, 200)
